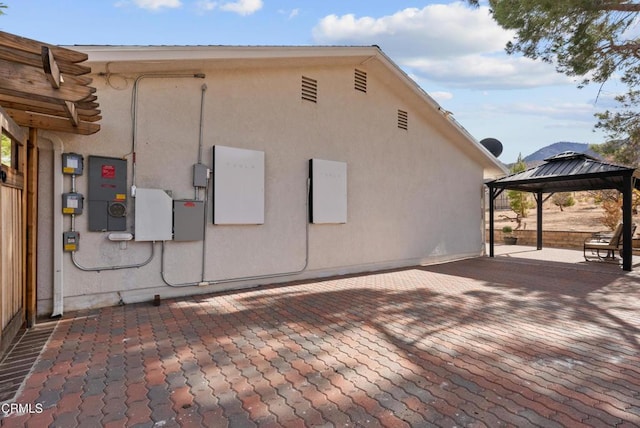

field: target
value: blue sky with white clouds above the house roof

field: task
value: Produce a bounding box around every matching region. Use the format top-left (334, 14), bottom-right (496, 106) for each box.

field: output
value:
top-left (0, 0), bottom-right (619, 163)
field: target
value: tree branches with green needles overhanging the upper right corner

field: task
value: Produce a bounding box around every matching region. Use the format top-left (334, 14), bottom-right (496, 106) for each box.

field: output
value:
top-left (467, 0), bottom-right (640, 166)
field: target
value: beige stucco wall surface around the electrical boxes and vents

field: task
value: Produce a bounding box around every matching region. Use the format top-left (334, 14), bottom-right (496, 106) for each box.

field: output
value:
top-left (38, 59), bottom-right (484, 314)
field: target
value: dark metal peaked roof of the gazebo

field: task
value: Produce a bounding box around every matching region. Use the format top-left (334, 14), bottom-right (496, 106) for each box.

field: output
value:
top-left (487, 152), bottom-right (640, 193)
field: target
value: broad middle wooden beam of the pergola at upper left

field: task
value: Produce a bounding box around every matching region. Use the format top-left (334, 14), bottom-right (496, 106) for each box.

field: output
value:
top-left (0, 61), bottom-right (95, 102)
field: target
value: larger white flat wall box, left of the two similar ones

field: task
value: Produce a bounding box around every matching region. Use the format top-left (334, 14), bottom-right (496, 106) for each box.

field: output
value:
top-left (213, 146), bottom-right (264, 224)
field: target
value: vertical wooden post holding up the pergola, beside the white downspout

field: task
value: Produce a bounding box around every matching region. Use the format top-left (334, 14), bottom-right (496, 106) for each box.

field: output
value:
top-left (25, 128), bottom-right (38, 327)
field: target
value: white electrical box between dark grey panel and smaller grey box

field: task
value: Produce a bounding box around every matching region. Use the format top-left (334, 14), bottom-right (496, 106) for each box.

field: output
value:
top-left (134, 188), bottom-right (173, 241)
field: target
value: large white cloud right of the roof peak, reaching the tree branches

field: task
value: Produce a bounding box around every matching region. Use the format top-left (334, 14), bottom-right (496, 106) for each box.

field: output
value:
top-left (313, 1), bottom-right (571, 89)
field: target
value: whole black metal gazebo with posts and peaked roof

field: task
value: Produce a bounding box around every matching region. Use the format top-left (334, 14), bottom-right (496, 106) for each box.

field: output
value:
top-left (486, 152), bottom-right (640, 271)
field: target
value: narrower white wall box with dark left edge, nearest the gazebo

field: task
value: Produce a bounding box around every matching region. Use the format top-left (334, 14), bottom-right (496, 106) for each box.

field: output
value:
top-left (309, 159), bottom-right (347, 224)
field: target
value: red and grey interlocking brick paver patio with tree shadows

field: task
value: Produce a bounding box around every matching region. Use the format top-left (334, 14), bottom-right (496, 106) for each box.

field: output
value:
top-left (0, 249), bottom-right (640, 428)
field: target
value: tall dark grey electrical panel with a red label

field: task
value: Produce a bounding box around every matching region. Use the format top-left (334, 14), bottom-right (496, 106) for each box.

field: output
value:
top-left (88, 156), bottom-right (127, 232)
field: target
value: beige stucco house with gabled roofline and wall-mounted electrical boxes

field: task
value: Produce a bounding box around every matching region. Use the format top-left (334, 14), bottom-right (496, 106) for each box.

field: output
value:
top-left (37, 46), bottom-right (505, 315)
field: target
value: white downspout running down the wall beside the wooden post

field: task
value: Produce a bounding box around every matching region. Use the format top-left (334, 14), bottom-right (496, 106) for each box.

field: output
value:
top-left (40, 131), bottom-right (64, 318)
